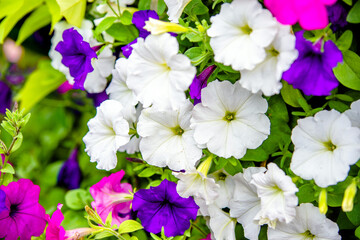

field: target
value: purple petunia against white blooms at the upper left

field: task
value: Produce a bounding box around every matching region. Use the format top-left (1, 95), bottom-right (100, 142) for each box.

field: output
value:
top-left (55, 28), bottom-right (97, 90)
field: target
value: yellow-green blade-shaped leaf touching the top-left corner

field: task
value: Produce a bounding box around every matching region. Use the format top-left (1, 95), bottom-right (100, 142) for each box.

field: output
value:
top-left (0, 0), bottom-right (43, 44)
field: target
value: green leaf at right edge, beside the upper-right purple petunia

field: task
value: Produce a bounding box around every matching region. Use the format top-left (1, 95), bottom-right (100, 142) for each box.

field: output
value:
top-left (333, 50), bottom-right (360, 91)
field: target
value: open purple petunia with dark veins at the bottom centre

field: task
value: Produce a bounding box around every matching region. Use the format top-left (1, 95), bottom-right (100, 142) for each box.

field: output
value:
top-left (132, 179), bottom-right (199, 237)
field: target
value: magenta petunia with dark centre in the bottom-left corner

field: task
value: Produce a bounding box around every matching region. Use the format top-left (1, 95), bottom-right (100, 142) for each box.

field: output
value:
top-left (0, 179), bottom-right (47, 240)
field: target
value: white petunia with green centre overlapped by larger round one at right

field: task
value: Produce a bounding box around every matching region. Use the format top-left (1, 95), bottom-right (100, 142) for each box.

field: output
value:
top-left (137, 100), bottom-right (202, 171)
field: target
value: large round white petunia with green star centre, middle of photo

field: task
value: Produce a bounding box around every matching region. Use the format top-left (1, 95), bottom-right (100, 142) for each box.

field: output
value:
top-left (191, 80), bottom-right (270, 158)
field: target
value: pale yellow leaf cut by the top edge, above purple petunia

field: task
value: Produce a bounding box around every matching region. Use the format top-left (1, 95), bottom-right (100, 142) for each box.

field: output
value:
top-left (56, 0), bottom-right (86, 28)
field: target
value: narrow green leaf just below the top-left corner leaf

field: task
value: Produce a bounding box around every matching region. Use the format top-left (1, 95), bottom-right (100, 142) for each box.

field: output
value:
top-left (16, 5), bottom-right (51, 45)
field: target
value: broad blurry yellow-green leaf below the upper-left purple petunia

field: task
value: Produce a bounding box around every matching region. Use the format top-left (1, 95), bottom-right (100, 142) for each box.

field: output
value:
top-left (15, 60), bottom-right (66, 112)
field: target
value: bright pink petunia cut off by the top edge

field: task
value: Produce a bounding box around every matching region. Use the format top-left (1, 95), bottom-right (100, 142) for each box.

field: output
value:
top-left (264, 0), bottom-right (336, 30)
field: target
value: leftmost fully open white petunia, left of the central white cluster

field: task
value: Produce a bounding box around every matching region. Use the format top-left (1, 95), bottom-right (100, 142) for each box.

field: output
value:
top-left (83, 100), bottom-right (130, 170)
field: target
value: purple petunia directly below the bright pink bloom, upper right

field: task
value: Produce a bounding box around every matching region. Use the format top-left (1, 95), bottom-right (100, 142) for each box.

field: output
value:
top-left (283, 31), bottom-right (343, 96)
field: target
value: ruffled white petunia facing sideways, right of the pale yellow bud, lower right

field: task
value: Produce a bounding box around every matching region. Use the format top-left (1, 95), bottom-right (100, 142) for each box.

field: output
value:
top-left (250, 163), bottom-right (299, 228)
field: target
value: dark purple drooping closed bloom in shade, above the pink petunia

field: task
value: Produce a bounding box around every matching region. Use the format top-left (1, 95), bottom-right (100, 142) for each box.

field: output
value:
top-left (58, 148), bottom-right (81, 189)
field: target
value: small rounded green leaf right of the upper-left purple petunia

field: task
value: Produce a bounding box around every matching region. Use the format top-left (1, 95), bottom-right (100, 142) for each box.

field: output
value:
top-left (106, 23), bottom-right (139, 44)
